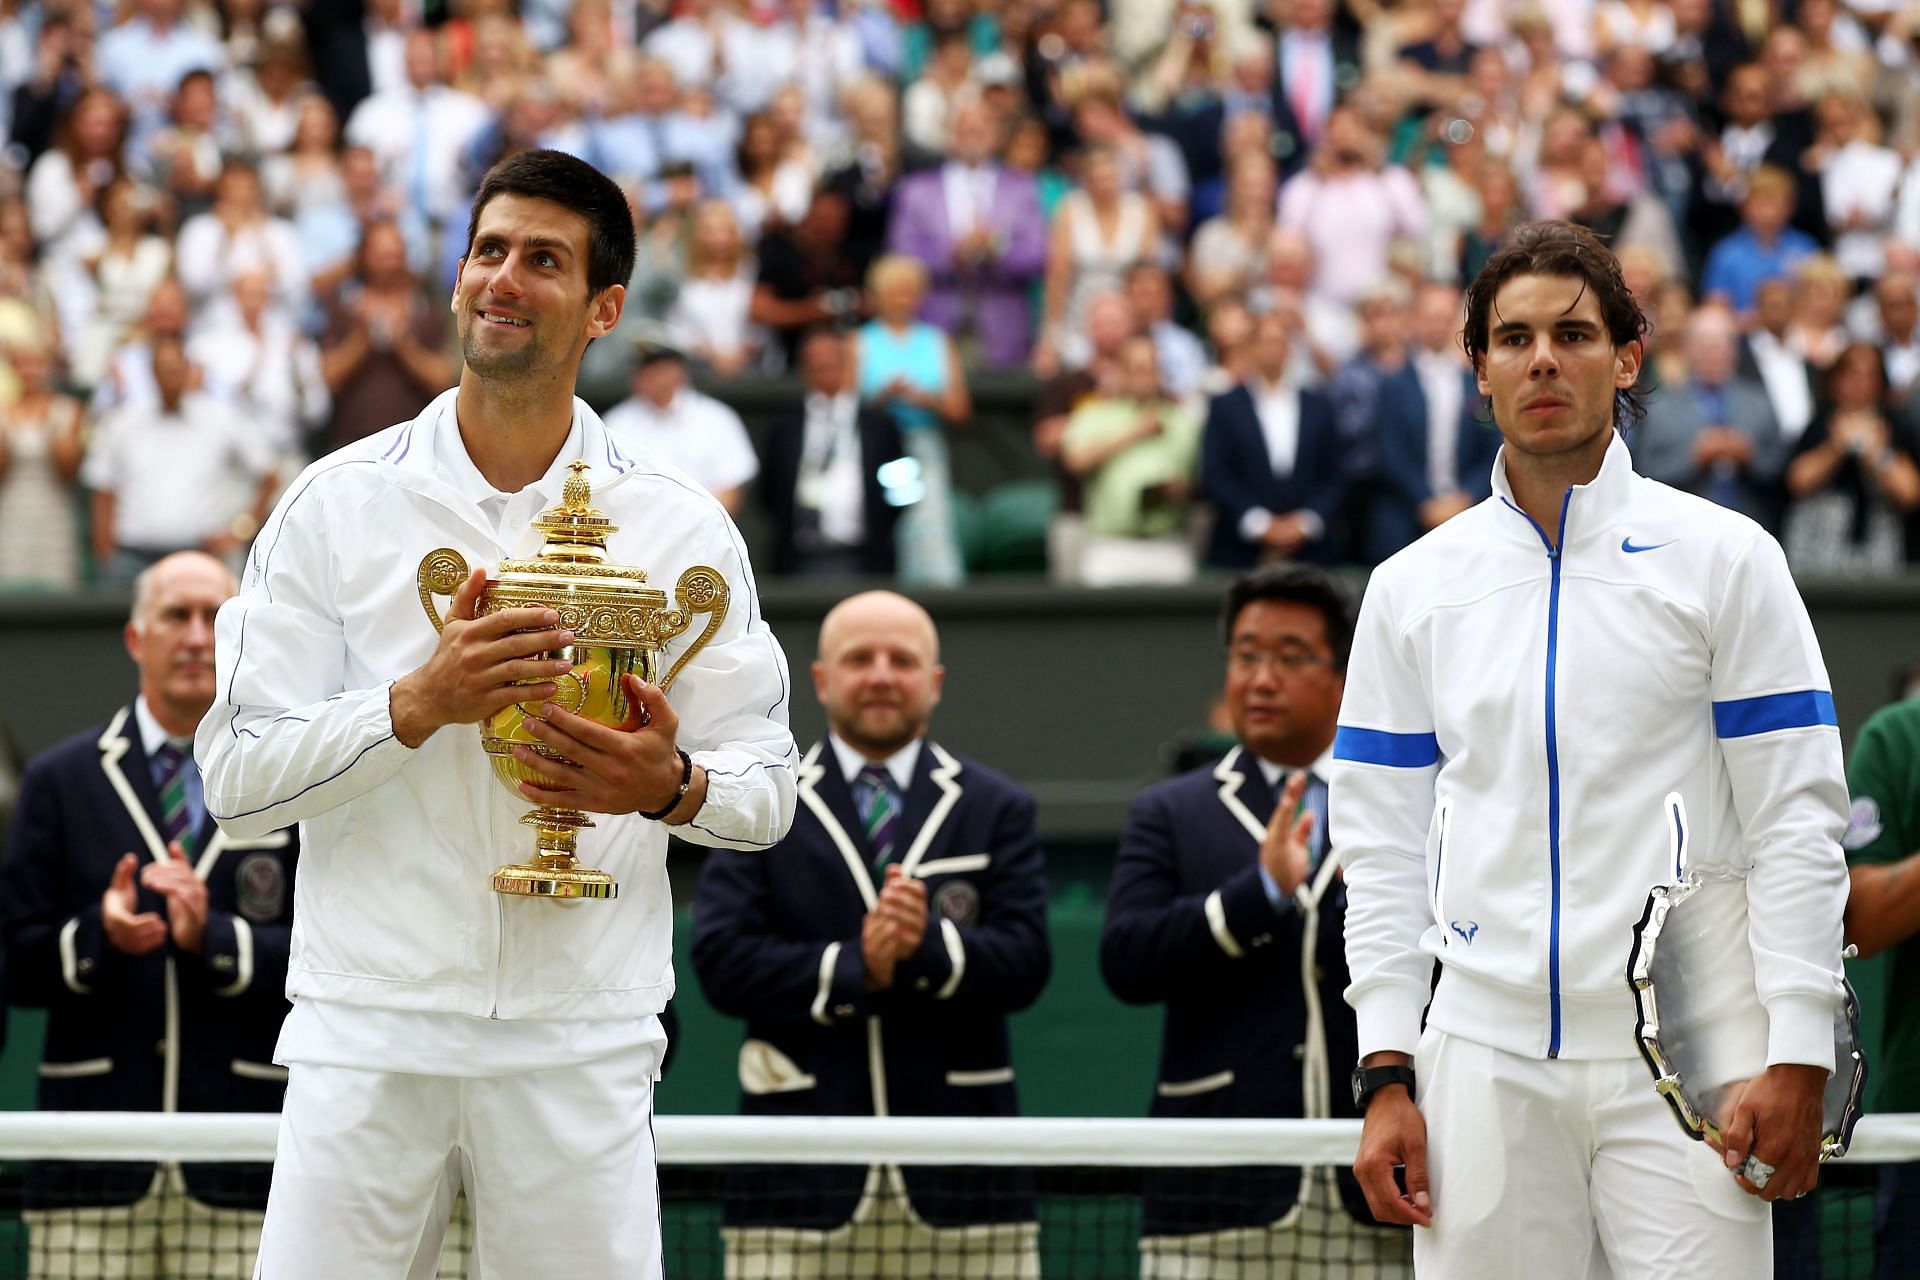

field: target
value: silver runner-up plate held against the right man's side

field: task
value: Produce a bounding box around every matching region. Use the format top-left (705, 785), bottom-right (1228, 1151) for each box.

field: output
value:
top-left (1626, 871), bottom-right (1866, 1182)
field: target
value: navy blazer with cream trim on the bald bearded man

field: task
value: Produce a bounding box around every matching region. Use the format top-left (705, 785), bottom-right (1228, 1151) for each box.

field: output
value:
top-left (693, 741), bottom-right (1052, 1230)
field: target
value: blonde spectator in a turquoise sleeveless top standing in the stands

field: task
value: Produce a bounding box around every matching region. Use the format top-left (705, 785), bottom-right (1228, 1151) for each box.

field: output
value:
top-left (856, 253), bottom-right (973, 587)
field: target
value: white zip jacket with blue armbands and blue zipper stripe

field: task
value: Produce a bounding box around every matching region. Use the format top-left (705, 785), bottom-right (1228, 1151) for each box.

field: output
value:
top-left (1329, 438), bottom-right (1847, 1071)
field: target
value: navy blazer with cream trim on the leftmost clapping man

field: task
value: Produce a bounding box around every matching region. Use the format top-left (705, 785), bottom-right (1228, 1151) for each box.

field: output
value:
top-left (0, 706), bottom-right (300, 1207)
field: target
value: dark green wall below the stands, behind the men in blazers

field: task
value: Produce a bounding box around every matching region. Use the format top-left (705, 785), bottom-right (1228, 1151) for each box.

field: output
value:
top-left (0, 580), bottom-right (1920, 1115)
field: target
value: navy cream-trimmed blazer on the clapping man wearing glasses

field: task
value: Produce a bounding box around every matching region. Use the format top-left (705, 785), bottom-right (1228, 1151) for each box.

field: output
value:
top-left (1100, 747), bottom-right (1373, 1236)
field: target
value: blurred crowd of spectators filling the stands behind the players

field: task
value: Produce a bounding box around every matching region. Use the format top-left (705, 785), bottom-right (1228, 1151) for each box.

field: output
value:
top-left (0, 0), bottom-right (1920, 591)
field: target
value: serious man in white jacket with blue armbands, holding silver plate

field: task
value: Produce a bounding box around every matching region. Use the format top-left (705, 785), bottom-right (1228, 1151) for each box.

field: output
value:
top-left (1331, 223), bottom-right (1853, 1280)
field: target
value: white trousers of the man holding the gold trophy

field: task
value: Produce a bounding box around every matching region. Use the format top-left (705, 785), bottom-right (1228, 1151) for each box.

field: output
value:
top-left (253, 1046), bottom-right (662, 1280)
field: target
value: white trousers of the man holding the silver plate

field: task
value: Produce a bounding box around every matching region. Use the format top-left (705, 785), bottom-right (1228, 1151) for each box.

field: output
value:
top-left (1413, 1027), bottom-right (1774, 1280)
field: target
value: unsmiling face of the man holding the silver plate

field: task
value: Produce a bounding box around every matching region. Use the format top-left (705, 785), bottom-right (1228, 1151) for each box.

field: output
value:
top-left (1475, 274), bottom-right (1640, 466)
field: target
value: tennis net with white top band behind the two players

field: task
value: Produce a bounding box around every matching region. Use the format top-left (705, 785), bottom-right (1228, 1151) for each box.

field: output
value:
top-left (0, 1113), bottom-right (1920, 1280)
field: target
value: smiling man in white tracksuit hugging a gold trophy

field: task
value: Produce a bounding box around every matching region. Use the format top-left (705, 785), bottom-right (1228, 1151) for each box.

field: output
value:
top-left (196, 152), bottom-right (795, 1280)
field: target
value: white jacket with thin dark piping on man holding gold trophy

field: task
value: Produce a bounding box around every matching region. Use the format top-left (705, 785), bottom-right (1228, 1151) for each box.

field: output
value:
top-left (194, 391), bottom-right (797, 1019)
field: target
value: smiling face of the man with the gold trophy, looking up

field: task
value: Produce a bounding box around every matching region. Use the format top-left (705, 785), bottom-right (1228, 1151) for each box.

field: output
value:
top-left (453, 196), bottom-right (626, 380)
